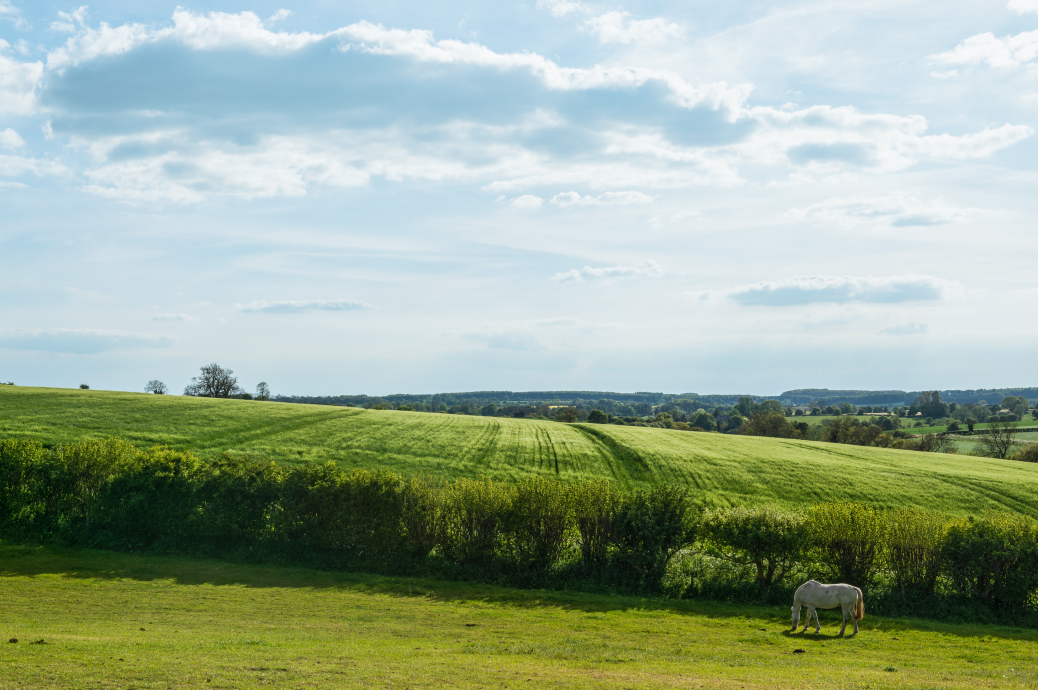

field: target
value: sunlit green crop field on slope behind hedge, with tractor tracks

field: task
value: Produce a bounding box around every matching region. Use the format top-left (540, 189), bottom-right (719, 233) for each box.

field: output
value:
top-left (6, 386), bottom-right (1038, 517)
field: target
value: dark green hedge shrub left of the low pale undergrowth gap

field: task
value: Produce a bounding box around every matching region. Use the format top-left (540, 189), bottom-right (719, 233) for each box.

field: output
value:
top-left (611, 487), bottom-right (700, 591)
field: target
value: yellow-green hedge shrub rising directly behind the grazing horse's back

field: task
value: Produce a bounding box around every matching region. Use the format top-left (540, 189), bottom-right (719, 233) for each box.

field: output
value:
top-left (808, 501), bottom-right (885, 587)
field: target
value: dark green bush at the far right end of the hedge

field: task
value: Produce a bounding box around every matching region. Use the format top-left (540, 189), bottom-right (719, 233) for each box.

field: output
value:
top-left (947, 513), bottom-right (1038, 608)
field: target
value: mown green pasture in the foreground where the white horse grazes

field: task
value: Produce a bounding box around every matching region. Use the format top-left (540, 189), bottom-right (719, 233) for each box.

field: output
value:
top-left (0, 545), bottom-right (1038, 689)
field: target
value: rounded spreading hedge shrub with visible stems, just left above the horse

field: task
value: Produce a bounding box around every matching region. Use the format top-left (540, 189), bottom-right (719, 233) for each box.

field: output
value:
top-left (703, 507), bottom-right (808, 587)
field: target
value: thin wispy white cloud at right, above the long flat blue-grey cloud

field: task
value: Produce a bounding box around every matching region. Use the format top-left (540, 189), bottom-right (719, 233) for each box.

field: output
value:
top-left (787, 192), bottom-right (989, 227)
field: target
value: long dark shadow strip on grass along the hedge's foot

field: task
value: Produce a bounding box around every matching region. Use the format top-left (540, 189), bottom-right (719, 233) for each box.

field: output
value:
top-left (0, 544), bottom-right (1038, 644)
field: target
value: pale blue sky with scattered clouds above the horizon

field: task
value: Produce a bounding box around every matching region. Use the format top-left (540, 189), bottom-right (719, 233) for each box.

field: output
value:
top-left (0, 0), bottom-right (1038, 395)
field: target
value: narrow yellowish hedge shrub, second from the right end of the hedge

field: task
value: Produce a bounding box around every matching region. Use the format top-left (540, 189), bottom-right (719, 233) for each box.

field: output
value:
top-left (883, 507), bottom-right (949, 595)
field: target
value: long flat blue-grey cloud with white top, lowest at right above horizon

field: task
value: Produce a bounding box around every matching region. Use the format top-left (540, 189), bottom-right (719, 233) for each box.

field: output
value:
top-left (728, 275), bottom-right (952, 306)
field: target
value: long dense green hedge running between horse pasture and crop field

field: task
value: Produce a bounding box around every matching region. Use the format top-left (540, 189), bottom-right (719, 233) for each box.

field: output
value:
top-left (6, 439), bottom-right (1038, 615)
